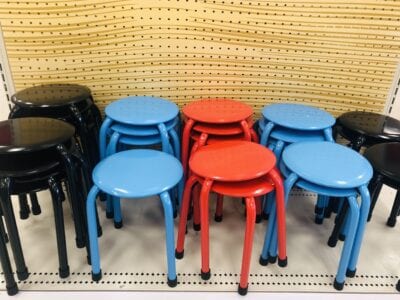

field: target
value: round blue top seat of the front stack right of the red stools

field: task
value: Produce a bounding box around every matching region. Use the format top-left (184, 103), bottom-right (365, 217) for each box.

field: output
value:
top-left (282, 142), bottom-right (373, 189)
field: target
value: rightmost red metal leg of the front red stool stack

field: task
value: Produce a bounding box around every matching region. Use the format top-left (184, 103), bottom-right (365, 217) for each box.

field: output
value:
top-left (268, 168), bottom-right (287, 267)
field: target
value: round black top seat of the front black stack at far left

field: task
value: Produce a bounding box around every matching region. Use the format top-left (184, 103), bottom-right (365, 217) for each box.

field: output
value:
top-left (0, 118), bottom-right (75, 153)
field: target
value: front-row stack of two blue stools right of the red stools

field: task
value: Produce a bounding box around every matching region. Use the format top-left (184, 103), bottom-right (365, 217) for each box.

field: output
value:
top-left (260, 142), bottom-right (373, 290)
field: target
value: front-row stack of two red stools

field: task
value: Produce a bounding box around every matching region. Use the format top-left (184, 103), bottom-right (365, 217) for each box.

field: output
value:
top-left (175, 142), bottom-right (287, 295)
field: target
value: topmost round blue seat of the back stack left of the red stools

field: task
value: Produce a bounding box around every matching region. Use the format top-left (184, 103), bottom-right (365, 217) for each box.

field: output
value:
top-left (105, 96), bottom-right (179, 126)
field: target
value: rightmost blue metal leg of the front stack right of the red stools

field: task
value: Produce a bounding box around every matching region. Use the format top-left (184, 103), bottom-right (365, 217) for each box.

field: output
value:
top-left (346, 185), bottom-right (371, 277)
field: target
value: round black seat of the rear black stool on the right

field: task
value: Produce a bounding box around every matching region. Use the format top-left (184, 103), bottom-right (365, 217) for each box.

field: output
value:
top-left (335, 111), bottom-right (400, 151)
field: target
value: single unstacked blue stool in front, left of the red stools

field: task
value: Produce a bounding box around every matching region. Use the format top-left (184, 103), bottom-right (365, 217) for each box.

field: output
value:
top-left (86, 149), bottom-right (183, 287)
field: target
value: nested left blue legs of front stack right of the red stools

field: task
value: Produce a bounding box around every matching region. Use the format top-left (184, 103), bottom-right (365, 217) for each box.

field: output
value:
top-left (260, 173), bottom-right (298, 265)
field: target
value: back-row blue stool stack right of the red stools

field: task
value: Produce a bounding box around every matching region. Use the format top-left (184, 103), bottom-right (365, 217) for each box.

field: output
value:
top-left (258, 103), bottom-right (335, 224)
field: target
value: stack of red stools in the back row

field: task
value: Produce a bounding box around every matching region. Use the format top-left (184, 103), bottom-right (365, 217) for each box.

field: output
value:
top-left (182, 99), bottom-right (258, 175)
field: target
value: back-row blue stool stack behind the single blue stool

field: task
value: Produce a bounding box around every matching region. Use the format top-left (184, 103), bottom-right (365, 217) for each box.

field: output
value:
top-left (99, 96), bottom-right (183, 220)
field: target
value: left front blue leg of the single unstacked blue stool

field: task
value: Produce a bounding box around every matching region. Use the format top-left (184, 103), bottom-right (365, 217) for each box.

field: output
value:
top-left (86, 186), bottom-right (101, 281)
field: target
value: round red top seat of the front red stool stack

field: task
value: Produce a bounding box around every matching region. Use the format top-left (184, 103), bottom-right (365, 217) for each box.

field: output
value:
top-left (189, 141), bottom-right (276, 181)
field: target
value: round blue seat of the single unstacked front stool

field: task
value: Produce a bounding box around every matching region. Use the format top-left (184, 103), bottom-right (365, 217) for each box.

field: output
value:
top-left (93, 149), bottom-right (183, 198)
